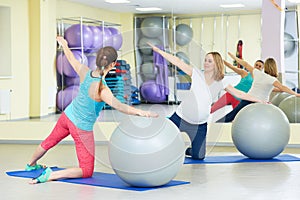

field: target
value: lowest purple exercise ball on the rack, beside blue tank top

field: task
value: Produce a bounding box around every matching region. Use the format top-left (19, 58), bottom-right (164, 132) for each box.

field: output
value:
top-left (56, 85), bottom-right (79, 111)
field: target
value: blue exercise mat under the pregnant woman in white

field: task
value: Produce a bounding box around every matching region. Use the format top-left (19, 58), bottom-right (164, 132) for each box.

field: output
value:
top-left (184, 154), bottom-right (300, 164)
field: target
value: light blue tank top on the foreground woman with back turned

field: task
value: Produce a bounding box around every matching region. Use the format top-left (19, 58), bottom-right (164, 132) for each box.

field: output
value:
top-left (64, 70), bottom-right (106, 131)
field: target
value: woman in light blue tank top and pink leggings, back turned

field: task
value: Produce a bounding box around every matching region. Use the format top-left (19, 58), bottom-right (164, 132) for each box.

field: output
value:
top-left (25, 37), bottom-right (158, 184)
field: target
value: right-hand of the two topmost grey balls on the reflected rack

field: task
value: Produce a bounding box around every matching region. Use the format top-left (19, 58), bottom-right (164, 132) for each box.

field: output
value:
top-left (175, 24), bottom-right (193, 46)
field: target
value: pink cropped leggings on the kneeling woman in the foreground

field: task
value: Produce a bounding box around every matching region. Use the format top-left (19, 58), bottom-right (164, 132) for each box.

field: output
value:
top-left (41, 113), bottom-right (95, 178)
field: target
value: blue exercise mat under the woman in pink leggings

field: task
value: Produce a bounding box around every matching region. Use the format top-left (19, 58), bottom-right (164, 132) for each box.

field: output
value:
top-left (6, 167), bottom-right (190, 191)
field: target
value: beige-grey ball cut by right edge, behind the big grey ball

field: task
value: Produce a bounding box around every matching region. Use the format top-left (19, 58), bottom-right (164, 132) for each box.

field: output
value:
top-left (279, 95), bottom-right (300, 123)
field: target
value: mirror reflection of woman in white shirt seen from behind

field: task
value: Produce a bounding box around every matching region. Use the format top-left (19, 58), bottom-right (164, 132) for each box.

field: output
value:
top-left (217, 53), bottom-right (300, 122)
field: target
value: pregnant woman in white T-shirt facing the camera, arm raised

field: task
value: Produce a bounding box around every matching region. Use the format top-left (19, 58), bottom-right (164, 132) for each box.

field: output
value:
top-left (149, 44), bottom-right (224, 160)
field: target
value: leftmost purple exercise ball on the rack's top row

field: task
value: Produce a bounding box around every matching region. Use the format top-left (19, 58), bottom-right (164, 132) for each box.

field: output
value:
top-left (64, 24), bottom-right (94, 49)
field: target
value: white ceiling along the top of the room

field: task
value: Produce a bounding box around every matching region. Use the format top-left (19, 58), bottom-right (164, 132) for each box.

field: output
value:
top-left (69, 0), bottom-right (295, 14)
